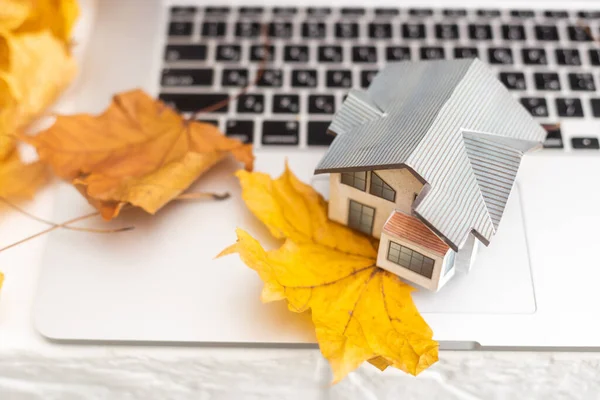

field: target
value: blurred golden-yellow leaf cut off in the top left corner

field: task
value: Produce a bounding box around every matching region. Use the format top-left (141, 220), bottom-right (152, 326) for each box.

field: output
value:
top-left (0, 0), bottom-right (79, 44)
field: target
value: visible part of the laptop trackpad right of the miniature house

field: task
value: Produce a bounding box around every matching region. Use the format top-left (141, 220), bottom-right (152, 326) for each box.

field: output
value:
top-left (414, 182), bottom-right (536, 314)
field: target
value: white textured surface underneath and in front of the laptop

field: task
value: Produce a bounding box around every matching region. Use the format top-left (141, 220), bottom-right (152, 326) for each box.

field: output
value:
top-left (0, 190), bottom-right (600, 400)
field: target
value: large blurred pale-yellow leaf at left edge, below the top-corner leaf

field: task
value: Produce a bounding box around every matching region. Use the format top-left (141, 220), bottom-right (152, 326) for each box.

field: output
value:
top-left (0, 31), bottom-right (76, 160)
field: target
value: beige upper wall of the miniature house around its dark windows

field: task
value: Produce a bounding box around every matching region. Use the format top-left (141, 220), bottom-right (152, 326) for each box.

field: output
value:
top-left (328, 168), bottom-right (423, 238)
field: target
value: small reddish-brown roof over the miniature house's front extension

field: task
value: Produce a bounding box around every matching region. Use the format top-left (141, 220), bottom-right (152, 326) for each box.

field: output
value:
top-left (383, 211), bottom-right (450, 257)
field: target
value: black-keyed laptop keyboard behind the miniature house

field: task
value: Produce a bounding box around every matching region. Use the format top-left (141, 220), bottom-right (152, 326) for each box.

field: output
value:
top-left (160, 6), bottom-right (600, 151)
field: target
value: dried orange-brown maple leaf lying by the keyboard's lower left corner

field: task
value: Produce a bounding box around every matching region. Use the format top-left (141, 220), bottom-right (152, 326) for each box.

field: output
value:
top-left (27, 90), bottom-right (254, 219)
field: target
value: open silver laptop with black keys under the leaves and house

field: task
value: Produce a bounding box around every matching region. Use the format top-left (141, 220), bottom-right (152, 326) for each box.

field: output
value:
top-left (34, 0), bottom-right (600, 349)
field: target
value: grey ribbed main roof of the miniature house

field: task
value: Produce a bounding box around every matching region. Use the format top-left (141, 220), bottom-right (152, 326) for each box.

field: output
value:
top-left (315, 59), bottom-right (546, 251)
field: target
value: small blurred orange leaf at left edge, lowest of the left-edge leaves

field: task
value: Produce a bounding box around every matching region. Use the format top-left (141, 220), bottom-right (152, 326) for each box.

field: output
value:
top-left (0, 151), bottom-right (48, 199)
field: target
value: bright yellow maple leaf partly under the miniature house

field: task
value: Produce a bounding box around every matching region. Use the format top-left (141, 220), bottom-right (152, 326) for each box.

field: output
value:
top-left (219, 167), bottom-right (438, 382)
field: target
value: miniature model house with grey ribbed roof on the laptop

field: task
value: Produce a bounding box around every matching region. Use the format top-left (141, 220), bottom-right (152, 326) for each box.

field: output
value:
top-left (315, 59), bottom-right (546, 290)
